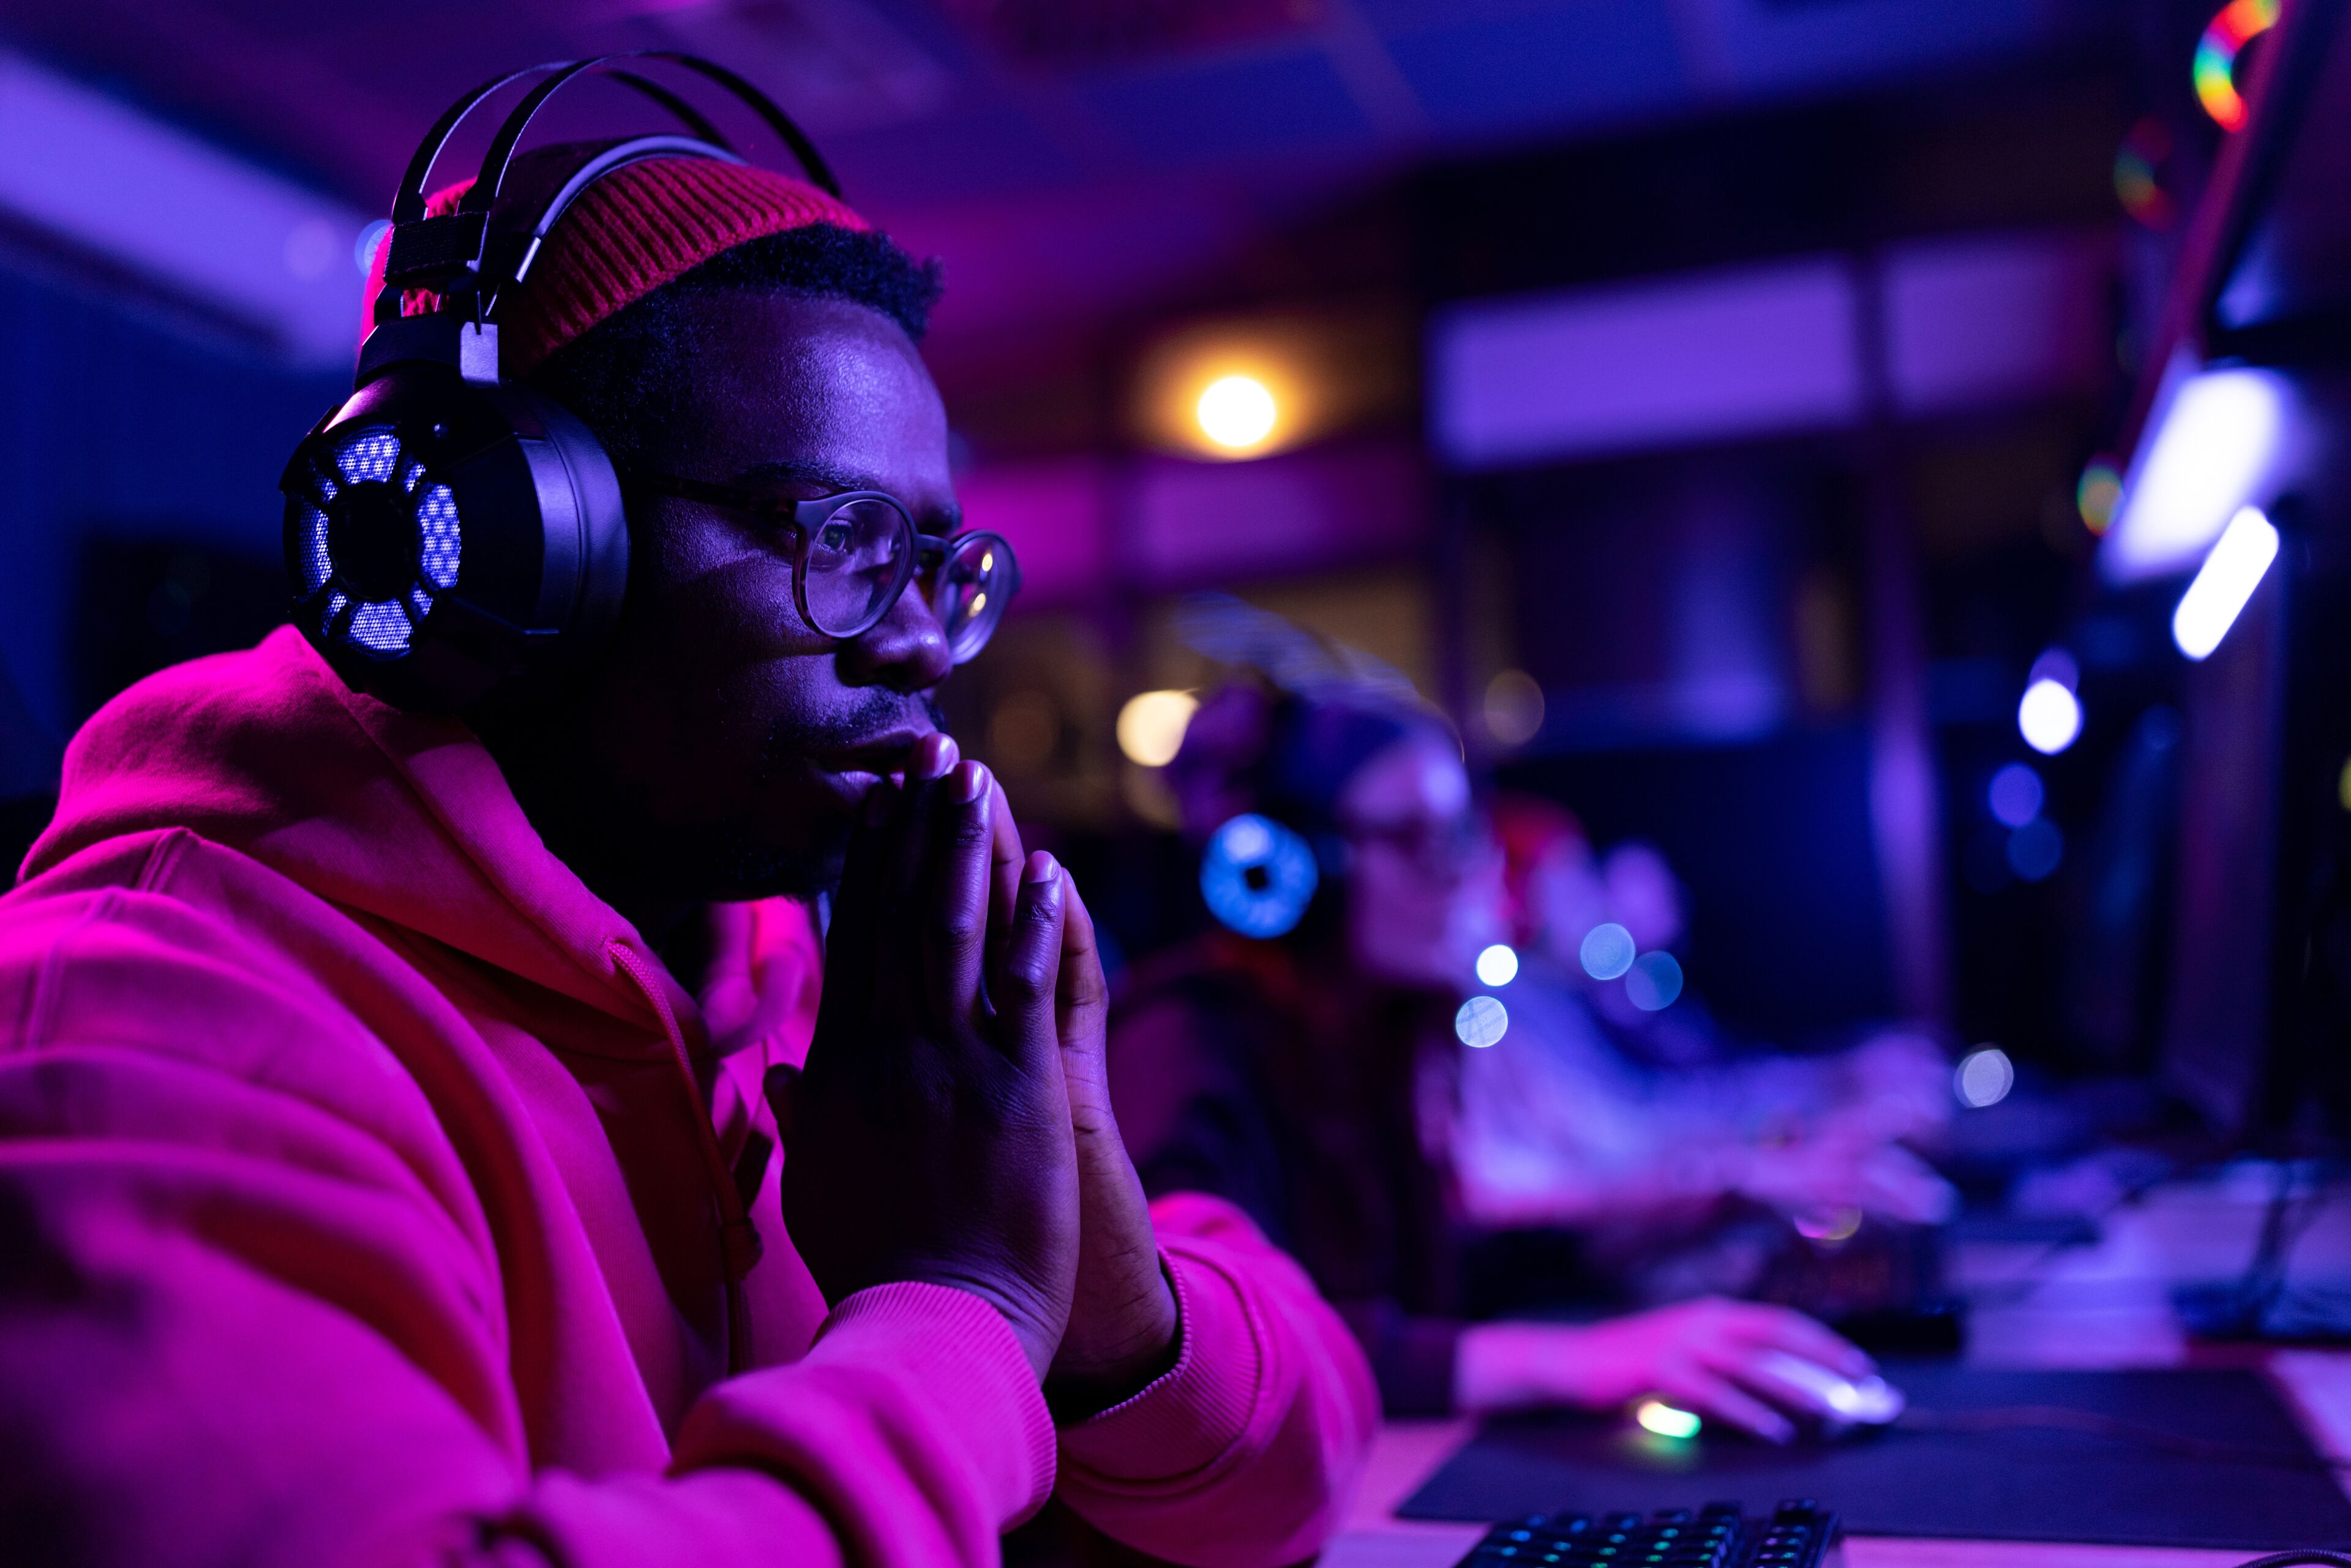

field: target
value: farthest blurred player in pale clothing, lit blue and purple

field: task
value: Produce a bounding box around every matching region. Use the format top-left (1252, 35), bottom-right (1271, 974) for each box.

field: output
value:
top-left (1446, 795), bottom-right (1956, 1300)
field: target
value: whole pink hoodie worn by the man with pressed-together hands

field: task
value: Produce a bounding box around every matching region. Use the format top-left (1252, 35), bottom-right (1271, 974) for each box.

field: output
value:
top-left (0, 630), bottom-right (1378, 1568)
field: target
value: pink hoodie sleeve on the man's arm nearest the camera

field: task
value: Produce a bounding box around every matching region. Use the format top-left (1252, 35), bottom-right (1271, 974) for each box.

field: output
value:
top-left (0, 877), bottom-right (1053, 1568)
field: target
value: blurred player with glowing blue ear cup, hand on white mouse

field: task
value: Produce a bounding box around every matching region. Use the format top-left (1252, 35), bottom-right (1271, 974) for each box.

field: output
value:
top-left (1109, 681), bottom-right (1869, 1441)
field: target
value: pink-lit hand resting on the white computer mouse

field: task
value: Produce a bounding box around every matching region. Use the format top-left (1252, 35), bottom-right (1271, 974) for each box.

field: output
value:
top-left (1453, 1297), bottom-right (1873, 1444)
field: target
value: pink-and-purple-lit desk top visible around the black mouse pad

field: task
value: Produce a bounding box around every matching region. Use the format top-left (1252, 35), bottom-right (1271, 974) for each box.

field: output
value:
top-left (1321, 1173), bottom-right (2351, 1568)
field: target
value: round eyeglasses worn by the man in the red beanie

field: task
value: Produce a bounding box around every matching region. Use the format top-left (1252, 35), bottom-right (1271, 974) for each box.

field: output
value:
top-left (621, 468), bottom-right (1021, 663)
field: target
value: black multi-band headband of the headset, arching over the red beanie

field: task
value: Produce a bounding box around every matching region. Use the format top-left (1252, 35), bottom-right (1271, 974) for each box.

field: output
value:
top-left (372, 50), bottom-right (842, 327)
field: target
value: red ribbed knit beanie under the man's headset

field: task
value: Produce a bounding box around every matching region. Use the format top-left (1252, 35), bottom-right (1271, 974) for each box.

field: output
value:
top-left (360, 157), bottom-right (872, 376)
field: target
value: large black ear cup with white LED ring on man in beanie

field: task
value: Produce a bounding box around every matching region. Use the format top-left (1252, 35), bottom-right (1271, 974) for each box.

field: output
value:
top-left (280, 367), bottom-right (628, 712)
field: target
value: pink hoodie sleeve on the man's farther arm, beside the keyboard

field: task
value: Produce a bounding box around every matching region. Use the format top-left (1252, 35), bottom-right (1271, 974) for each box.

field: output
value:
top-left (1060, 1195), bottom-right (1380, 1568)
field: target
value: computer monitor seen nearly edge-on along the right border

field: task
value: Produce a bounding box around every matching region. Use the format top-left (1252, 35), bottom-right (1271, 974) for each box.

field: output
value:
top-left (2134, 0), bottom-right (2351, 1154)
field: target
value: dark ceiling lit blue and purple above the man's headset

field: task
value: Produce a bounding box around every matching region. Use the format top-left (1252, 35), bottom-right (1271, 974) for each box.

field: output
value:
top-left (0, 0), bottom-right (2123, 376)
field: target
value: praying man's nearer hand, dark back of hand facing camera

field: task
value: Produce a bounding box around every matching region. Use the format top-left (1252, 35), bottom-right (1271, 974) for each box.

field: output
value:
top-left (769, 736), bottom-right (1079, 1378)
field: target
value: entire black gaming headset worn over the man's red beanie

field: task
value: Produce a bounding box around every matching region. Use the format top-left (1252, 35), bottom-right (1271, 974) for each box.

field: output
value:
top-left (277, 50), bottom-right (842, 712)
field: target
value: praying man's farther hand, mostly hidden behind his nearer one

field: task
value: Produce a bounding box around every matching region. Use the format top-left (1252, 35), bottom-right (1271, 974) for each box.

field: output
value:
top-left (969, 792), bottom-right (1178, 1417)
